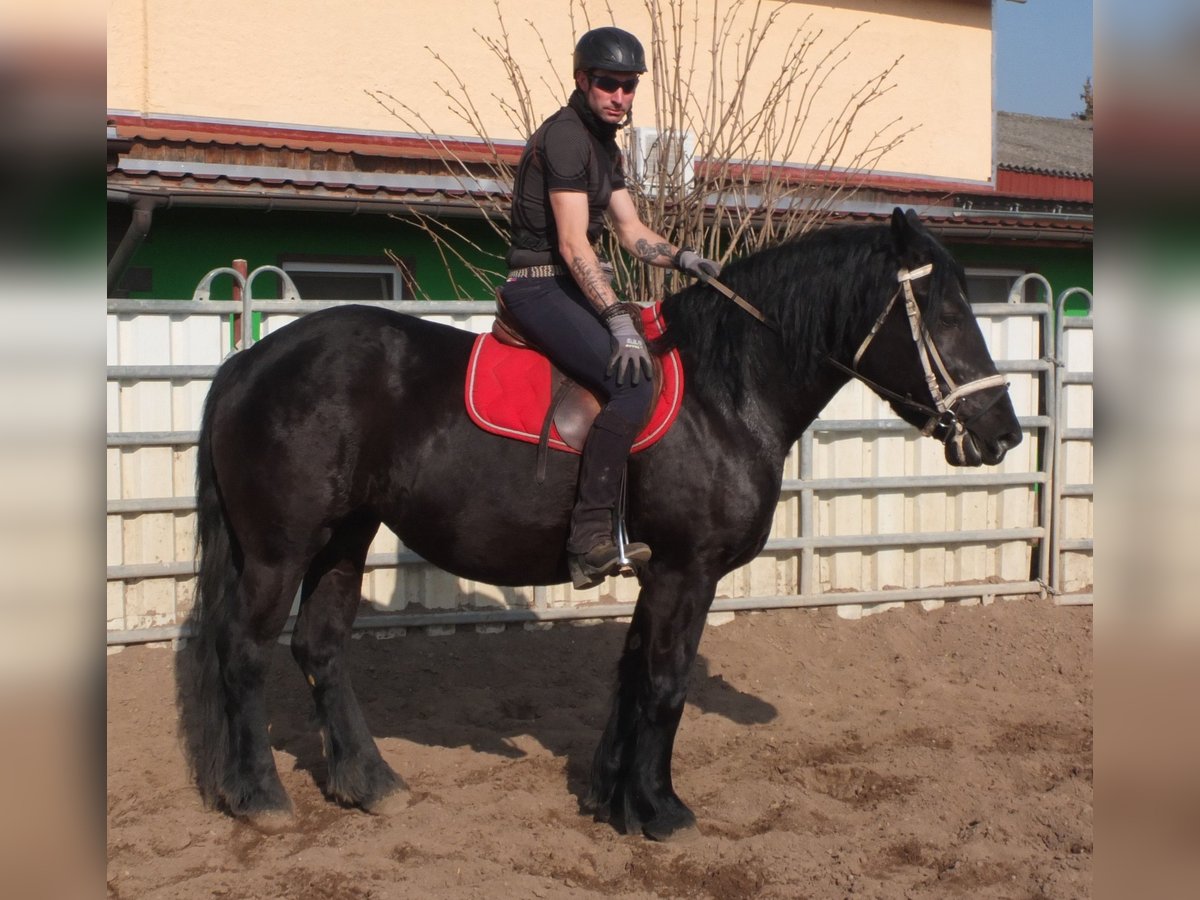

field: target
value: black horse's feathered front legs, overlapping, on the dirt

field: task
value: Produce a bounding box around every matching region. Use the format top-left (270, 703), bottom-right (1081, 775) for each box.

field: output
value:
top-left (586, 563), bottom-right (716, 840)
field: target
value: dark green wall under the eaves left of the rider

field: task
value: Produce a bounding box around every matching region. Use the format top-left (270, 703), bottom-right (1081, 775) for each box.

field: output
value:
top-left (130, 208), bottom-right (505, 300)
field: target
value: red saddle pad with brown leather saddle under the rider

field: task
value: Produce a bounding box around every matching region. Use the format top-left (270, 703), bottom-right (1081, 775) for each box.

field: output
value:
top-left (466, 292), bottom-right (683, 481)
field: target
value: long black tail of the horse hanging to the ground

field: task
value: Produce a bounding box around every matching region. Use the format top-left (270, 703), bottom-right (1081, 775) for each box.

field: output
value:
top-left (176, 353), bottom-right (242, 806)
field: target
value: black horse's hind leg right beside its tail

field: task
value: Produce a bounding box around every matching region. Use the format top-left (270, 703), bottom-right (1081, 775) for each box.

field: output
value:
top-left (216, 560), bottom-right (300, 824)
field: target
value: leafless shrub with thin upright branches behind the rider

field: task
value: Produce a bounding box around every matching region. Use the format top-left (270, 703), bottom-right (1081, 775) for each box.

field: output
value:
top-left (367, 0), bottom-right (911, 300)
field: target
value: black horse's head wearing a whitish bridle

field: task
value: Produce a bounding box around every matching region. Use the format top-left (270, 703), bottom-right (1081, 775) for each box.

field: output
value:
top-left (850, 209), bottom-right (1021, 466)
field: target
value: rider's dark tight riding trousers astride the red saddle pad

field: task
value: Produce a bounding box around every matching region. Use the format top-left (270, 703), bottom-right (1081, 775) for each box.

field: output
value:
top-left (502, 275), bottom-right (654, 553)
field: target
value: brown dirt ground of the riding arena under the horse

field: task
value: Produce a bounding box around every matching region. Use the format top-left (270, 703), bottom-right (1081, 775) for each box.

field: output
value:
top-left (108, 599), bottom-right (1092, 900)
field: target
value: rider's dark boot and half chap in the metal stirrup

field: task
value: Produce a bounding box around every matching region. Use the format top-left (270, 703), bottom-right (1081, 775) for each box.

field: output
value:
top-left (566, 408), bottom-right (650, 588)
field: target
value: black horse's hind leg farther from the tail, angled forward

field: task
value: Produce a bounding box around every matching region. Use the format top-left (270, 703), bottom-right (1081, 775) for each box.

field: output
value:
top-left (292, 521), bottom-right (407, 812)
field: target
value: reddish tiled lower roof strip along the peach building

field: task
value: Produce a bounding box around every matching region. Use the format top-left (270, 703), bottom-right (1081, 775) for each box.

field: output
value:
top-left (108, 114), bottom-right (1093, 239)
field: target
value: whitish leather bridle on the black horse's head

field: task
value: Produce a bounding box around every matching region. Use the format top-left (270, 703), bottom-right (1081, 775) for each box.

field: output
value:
top-left (826, 263), bottom-right (1008, 443)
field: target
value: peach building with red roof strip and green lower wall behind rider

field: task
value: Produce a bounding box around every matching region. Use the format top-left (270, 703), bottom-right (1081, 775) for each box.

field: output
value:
top-left (107, 0), bottom-right (1092, 300)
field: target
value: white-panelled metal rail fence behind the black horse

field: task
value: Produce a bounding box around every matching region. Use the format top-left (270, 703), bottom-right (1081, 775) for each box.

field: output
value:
top-left (107, 285), bottom-right (1092, 644)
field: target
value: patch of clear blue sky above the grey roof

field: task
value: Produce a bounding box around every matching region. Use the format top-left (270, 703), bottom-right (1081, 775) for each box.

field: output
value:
top-left (992, 0), bottom-right (1094, 119)
